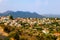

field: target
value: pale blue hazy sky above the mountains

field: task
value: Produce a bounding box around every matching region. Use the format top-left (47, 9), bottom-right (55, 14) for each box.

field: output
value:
top-left (0, 0), bottom-right (60, 14)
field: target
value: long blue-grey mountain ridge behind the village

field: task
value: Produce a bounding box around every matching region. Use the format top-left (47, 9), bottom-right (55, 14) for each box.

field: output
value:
top-left (0, 11), bottom-right (44, 18)
